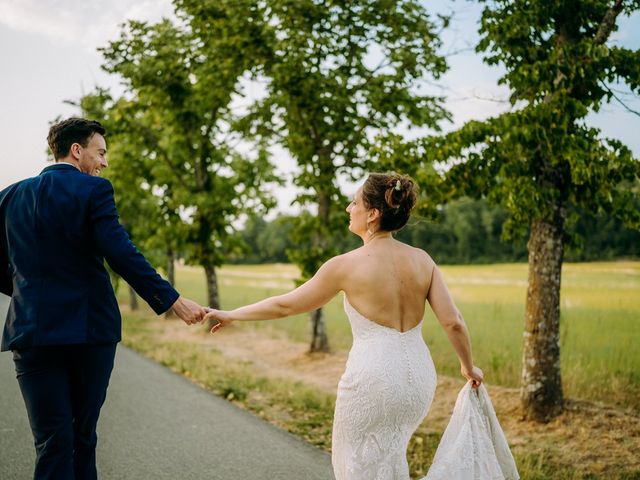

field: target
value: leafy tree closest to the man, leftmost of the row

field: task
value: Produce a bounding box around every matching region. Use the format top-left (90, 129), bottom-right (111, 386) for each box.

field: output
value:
top-left (94, 19), bottom-right (277, 314)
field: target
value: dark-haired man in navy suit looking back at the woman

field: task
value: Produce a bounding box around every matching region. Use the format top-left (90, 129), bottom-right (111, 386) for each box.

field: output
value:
top-left (0, 118), bottom-right (206, 480)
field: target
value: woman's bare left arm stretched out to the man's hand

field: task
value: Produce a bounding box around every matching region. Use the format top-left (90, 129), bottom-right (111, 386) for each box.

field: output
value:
top-left (205, 256), bottom-right (344, 324)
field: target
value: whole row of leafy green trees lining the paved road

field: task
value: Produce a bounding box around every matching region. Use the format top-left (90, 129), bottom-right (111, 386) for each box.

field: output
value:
top-left (80, 0), bottom-right (640, 420)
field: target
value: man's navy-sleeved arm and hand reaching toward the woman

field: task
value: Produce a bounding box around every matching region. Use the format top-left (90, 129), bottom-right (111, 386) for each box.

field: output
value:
top-left (90, 179), bottom-right (206, 324)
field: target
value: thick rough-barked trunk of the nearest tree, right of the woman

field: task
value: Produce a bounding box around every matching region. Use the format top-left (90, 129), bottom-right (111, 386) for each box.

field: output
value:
top-left (520, 219), bottom-right (563, 422)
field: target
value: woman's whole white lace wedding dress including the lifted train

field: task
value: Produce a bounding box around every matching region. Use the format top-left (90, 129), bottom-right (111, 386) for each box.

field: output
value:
top-left (332, 295), bottom-right (519, 480)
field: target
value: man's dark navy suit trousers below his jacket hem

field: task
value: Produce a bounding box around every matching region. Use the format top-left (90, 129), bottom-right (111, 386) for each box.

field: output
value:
top-left (13, 343), bottom-right (116, 480)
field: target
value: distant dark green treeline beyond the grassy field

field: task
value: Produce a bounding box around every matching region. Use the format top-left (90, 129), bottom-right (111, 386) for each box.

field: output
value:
top-left (230, 198), bottom-right (640, 264)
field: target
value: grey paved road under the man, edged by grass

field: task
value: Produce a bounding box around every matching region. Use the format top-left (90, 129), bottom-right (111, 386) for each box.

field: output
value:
top-left (0, 295), bottom-right (333, 480)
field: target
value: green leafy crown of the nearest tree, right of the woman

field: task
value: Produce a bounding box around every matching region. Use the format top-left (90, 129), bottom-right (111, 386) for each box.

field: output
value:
top-left (376, 0), bottom-right (640, 238)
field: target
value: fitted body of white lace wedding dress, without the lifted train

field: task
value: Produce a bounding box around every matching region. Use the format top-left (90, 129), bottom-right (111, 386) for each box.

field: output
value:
top-left (332, 295), bottom-right (436, 480)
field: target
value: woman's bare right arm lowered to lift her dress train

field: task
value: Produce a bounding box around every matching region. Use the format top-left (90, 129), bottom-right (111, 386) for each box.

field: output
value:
top-left (427, 265), bottom-right (482, 386)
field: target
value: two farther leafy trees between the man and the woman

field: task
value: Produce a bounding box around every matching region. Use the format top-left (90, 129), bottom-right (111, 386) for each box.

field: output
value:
top-left (80, 0), bottom-right (447, 350)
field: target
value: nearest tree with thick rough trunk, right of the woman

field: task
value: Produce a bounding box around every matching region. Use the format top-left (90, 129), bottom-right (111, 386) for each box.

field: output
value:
top-left (379, 0), bottom-right (640, 421)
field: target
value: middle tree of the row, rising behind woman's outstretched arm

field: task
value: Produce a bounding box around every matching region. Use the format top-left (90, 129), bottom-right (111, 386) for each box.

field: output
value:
top-left (178, 0), bottom-right (446, 351)
